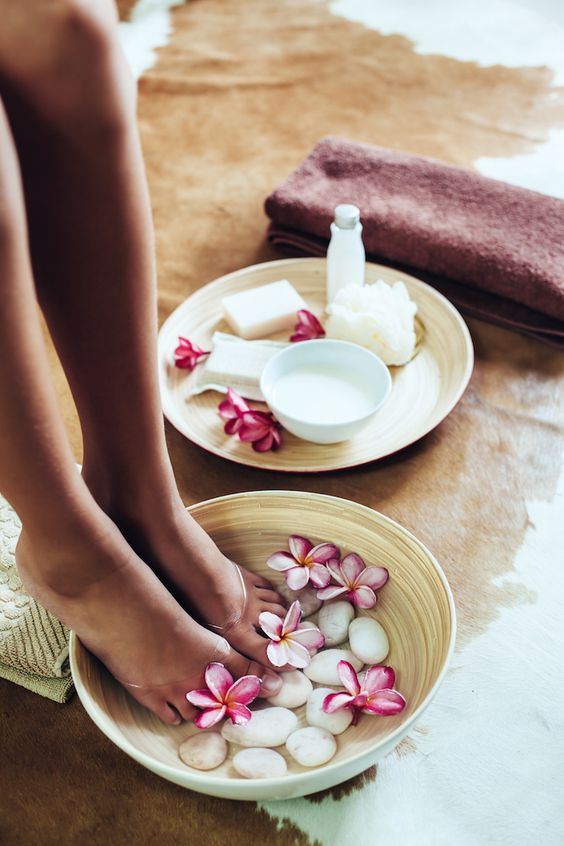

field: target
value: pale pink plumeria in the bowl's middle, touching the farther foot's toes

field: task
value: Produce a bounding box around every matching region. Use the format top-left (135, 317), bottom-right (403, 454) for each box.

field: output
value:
top-left (259, 599), bottom-right (325, 669)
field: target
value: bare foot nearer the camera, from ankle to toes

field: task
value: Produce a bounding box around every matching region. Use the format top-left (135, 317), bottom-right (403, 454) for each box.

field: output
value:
top-left (16, 516), bottom-right (280, 724)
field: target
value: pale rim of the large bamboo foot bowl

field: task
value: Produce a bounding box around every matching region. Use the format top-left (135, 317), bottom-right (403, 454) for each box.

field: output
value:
top-left (69, 491), bottom-right (456, 799)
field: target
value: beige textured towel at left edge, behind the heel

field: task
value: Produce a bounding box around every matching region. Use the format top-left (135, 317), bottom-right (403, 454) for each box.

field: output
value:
top-left (0, 496), bottom-right (73, 702)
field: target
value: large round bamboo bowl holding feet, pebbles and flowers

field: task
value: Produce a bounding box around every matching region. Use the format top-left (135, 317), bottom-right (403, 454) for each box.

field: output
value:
top-left (70, 491), bottom-right (456, 800)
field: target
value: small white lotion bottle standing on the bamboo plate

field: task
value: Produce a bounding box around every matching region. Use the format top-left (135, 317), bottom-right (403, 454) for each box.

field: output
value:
top-left (327, 203), bottom-right (366, 305)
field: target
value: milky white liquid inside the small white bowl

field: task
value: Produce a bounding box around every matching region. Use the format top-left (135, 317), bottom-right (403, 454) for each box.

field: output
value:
top-left (272, 364), bottom-right (374, 423)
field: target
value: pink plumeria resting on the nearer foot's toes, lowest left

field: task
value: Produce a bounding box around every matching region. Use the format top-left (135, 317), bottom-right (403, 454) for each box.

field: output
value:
top-left (186, 663), bottom-right (260, 729)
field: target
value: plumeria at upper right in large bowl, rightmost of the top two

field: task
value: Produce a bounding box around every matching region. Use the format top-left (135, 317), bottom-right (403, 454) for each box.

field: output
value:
top-left (317, 552), bottom-right (388, 608)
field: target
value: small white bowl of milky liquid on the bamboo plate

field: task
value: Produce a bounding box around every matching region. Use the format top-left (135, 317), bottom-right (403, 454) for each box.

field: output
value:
top-left (260, 338), bottom-right (392, 444)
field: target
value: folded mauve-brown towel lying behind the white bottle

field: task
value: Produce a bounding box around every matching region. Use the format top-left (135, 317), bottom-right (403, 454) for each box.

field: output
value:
top-left (265, 138), bottom-right (564, 346)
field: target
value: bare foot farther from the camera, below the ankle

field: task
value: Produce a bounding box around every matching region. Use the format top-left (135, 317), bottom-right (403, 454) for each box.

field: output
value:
top-left (82, 477), bottom-right (287, 667)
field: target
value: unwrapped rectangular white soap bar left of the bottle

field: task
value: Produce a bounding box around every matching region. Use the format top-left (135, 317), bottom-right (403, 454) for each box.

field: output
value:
top-left (221, 279), bottom-right (307, 340)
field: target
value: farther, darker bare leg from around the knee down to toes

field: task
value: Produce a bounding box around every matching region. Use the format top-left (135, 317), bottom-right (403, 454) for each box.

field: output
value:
top-left (1, 3), bottom-right (285, 664)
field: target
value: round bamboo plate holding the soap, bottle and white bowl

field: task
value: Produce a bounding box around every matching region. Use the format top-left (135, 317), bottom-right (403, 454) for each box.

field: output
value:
top-left (159, 258), bottom-right (474, 473)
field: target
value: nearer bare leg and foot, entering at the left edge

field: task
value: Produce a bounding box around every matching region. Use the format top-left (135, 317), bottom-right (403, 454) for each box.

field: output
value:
top-left (0, 94), bottom-right (282, 722)
